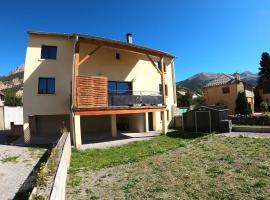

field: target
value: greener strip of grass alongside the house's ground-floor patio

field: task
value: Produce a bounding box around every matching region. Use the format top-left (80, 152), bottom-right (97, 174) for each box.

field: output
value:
top-left (70, 132), bottom-right (204, 173)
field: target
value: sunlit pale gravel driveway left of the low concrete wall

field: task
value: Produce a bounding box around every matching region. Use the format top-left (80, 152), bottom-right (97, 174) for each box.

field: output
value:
top-left (0, 144), bottom-right (46, 200)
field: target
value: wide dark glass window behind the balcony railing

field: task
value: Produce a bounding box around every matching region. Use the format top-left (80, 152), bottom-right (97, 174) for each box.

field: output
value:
top-left (108, 81), bottom-right (132, 94)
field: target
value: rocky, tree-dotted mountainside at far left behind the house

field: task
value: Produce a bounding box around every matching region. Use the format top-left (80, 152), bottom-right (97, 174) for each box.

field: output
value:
top-left (0, 64), bottom-right (24, 97)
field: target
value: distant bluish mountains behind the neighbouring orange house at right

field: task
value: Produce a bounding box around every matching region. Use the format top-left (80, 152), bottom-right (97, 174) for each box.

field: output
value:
top-left (176, 71), bottom-right (258, 91)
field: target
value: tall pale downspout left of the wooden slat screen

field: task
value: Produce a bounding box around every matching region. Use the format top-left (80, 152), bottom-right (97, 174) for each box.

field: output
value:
top-left (70, 35), bottom-right (79, 148)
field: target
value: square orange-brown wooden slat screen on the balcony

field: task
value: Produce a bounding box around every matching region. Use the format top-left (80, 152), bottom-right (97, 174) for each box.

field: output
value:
top-left (77, 76), bottom-right (108, 108)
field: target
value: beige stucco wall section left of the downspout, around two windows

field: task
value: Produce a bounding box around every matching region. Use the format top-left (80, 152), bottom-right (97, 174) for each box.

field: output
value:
top-left (23, 35), bottom-right (73, 122)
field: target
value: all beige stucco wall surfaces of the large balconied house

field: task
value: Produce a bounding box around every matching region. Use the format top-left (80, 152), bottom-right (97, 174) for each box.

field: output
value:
top-left (24, 34), bottom-right (175, 134)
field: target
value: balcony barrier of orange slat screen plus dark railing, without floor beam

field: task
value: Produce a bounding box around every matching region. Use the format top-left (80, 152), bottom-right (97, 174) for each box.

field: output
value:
top-left (75, 76), bottom-right (163, 109)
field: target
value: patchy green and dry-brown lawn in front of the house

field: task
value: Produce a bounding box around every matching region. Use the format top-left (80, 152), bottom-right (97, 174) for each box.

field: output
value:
top-left (67, 133), bottom-right (270, 199)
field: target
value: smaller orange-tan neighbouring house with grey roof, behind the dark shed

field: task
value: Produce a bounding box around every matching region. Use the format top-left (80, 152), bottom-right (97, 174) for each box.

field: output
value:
top-left (204, 73), bottom-right (254, 115)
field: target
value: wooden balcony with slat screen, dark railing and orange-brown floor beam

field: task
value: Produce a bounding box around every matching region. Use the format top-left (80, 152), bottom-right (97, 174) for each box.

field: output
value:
top-left (74, 76), bottom-right (165, 115)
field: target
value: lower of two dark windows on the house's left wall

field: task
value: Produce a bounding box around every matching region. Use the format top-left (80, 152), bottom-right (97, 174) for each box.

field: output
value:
top-left (38, 78), bottom-right (55, 94)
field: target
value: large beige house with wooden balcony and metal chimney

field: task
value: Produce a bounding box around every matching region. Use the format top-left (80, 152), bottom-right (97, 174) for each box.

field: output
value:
top-left (23, 32), bottom-right (176, 146)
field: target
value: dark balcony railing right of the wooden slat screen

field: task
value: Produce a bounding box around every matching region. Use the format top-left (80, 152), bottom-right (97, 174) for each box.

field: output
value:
top-left (108, 90), bottom-right (163, 106)
